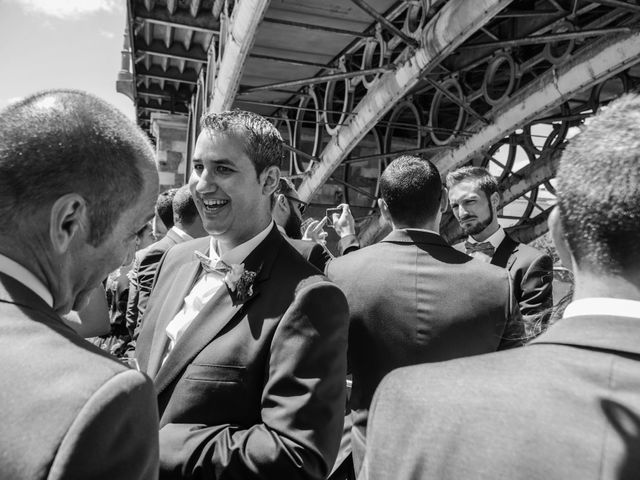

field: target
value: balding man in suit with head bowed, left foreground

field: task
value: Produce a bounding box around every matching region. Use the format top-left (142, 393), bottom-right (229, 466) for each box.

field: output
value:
top-left (0, 90), bottom-right (158, 480)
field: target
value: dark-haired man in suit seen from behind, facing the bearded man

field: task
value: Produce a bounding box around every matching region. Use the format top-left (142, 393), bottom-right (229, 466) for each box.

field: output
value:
top-left (327, 156), bottom-right (524, 472)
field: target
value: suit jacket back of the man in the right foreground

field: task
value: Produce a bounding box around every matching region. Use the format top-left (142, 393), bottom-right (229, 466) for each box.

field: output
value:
top-left (361, 316), bottom-right (640, 480)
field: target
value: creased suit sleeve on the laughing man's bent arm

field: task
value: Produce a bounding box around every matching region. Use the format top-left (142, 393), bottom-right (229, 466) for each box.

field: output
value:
top-left (160, 282), bottom-right (348, 480)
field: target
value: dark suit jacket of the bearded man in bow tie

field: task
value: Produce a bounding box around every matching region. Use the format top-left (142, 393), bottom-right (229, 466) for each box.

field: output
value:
top-left (491, 235), bottom-right (553, 336)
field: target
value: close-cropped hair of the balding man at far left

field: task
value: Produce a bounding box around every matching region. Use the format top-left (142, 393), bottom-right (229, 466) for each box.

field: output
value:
top-left (0, 90), bottom-right (153, 246)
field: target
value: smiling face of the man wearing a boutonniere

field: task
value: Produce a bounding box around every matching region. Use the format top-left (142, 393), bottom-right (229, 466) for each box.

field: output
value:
top-left (189, 130), bottom-right (271, 247)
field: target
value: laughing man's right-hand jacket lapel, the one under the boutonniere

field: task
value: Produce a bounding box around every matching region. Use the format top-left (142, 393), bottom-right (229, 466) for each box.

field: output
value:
top-left (154, 226), bottom-right (284, 394)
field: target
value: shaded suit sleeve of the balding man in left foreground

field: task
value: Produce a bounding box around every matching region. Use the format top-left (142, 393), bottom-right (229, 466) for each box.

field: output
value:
top-left (48, 370), bottom-right (158, 480)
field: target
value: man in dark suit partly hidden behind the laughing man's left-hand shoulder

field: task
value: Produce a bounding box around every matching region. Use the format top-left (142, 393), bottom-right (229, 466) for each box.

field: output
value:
top-left (126, 185), bottom-right (207, 342)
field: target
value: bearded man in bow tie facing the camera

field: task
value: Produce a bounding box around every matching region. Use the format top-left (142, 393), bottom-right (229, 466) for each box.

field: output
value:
top-left (446, 167), bottom-right (553, 338)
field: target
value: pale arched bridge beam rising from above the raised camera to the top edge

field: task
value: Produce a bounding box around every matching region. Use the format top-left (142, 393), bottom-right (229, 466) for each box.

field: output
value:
top-left (298, 0), bottom-right (511, 201)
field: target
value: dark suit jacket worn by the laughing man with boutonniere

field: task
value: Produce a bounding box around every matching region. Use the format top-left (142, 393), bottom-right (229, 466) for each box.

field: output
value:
top-left (137, 226), bottom-right (348, 480)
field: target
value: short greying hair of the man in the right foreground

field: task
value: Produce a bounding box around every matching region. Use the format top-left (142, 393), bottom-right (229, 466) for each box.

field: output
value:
top-left (557, 95), bottom-right (640, 274)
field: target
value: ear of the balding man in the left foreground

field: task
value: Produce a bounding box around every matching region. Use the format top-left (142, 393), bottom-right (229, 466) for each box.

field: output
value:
top-left (49, 193), bottom-right (89, 254)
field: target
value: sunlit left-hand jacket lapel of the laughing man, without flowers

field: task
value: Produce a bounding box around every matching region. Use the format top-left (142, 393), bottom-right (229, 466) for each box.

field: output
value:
top-left (146, 253), bottom-right (201, 378)
